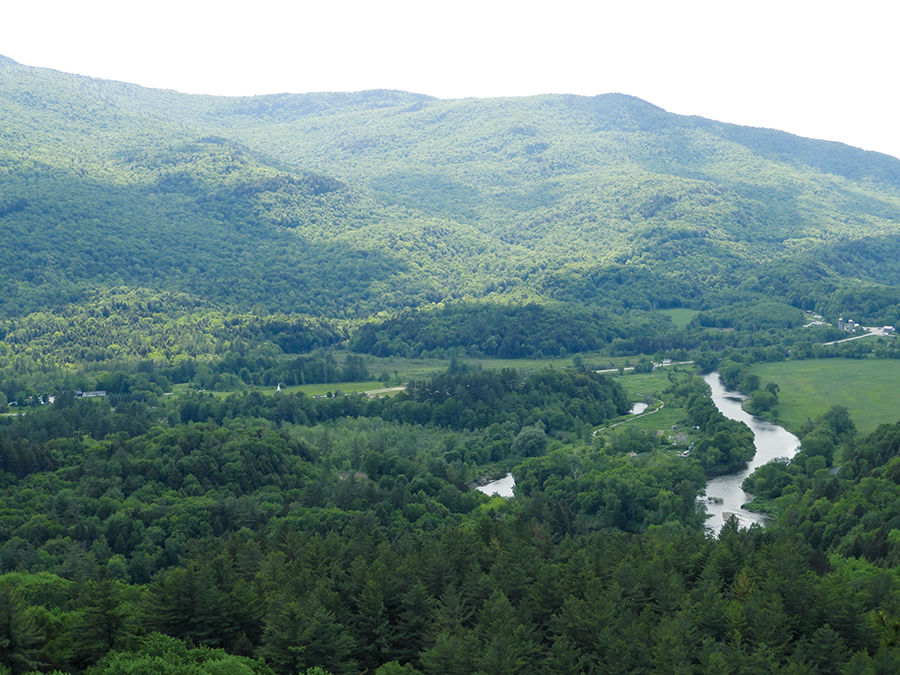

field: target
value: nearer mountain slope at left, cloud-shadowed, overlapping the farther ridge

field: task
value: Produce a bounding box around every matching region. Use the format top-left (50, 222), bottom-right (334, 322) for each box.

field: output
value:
top-left (0, 61), bottom-right (528, 316)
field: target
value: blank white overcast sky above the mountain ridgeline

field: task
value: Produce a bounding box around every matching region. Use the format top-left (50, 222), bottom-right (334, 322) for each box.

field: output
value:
top-left (0, 0), bottom-right (900, 157)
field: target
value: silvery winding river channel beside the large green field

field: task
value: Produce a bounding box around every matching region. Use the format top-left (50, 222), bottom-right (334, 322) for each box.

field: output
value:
top-left (703, 372), bottom-right (800, 533)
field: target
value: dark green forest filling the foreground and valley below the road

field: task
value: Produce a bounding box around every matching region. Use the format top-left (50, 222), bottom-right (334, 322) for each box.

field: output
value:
top-left (0, 371), bottom-right (900, 674)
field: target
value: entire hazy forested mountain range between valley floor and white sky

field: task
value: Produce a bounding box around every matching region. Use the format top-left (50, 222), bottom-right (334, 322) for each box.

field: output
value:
top-left (0, 59), bottom-right (900, 316)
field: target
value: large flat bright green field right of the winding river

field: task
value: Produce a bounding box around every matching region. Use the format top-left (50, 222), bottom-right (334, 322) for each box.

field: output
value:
top-left (752, 359), bottom-right (900, 434)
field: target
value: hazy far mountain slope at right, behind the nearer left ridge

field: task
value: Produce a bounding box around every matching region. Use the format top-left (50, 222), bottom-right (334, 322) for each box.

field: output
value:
top-left (225, 94), bottom-right (900, 264)
